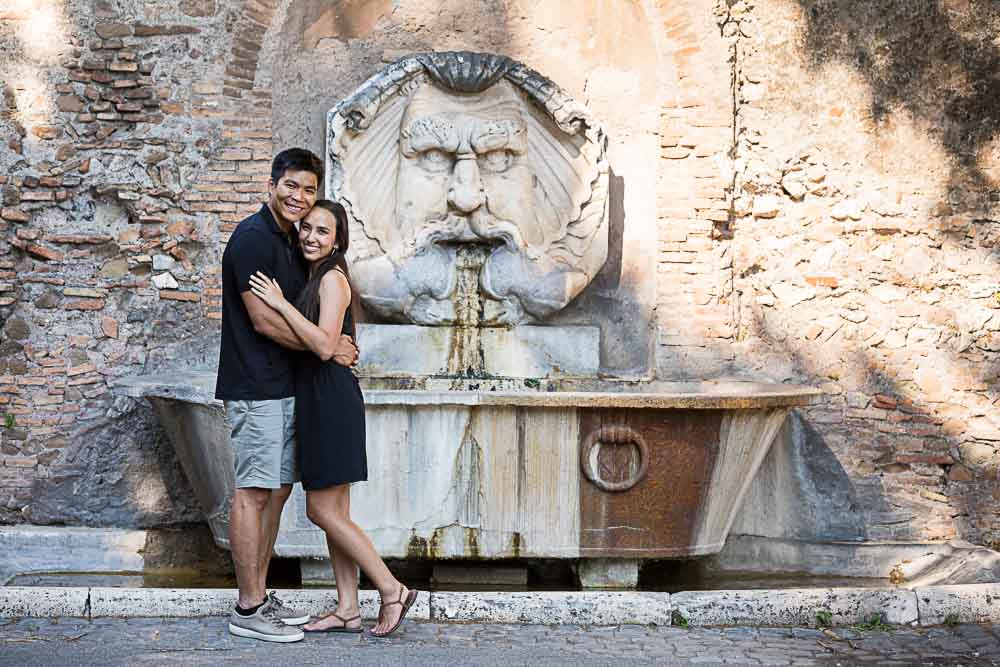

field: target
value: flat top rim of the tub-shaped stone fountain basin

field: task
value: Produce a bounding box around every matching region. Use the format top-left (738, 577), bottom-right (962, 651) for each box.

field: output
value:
top-left (113, 370), bottom-right (824, 410)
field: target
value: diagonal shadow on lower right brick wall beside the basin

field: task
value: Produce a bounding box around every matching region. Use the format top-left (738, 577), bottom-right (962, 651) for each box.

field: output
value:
top-left (741, 308), bottom-right (1000, 548)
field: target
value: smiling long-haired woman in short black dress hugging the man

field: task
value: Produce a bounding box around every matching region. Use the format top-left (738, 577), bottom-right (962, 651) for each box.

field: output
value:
top-left (250, 199), bottom-right (417, 637)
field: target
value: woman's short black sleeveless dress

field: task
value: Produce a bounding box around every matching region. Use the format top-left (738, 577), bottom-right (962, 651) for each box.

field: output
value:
top-left (295, 308), bottom-right (368, 491)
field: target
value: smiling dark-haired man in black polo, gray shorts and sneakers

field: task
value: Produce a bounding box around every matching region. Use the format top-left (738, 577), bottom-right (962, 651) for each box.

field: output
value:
top-left (215, 148), bottom-right (357, 642)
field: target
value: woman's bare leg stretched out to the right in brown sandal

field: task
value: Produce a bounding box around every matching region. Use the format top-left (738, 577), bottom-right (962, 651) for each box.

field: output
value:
top-left (306, 484), bottom-right (409, 634)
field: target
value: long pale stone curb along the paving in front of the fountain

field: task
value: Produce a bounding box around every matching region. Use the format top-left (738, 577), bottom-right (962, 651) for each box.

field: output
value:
top-left (0, 584), bottom-right (1000, 626)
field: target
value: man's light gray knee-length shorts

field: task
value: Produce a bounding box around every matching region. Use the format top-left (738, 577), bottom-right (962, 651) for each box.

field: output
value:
top-left (225, 398), bottom-right (299, 489)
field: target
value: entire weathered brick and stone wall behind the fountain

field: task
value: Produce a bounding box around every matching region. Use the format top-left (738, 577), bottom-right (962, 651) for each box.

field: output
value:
top-left (0, 0), bottom-right (1000, 544)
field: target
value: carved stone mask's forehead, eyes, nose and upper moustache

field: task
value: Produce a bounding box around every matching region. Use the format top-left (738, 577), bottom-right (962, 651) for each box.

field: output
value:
top-left (390, 82), bottom-right (543, 254)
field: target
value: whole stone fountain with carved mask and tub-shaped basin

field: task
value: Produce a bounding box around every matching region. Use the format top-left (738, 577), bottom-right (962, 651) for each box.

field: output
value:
top-left (120, 52), bottom-right (818, 585)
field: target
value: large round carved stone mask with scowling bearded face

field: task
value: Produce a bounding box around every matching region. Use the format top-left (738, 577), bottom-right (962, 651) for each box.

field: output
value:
top-left (326, 52), bottom-right (608, 326)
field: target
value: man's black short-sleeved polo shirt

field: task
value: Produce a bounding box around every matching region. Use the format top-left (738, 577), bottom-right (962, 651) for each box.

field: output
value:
top-left (215, 204), bottom-right (306, 401)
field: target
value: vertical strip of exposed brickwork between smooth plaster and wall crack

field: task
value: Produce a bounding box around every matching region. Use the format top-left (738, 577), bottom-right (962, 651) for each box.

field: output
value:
top-left (656, 2), bottom-right (733, 378)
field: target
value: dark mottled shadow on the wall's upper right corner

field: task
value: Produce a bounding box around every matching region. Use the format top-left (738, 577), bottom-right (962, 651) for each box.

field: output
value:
top-left (798, 0), bottom-right (1000, 206)
